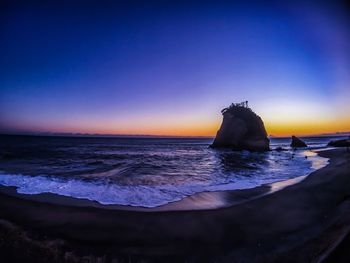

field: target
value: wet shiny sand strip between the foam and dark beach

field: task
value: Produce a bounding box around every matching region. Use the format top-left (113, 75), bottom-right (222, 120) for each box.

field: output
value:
top-left (0, 148), bottom-right (329, 212)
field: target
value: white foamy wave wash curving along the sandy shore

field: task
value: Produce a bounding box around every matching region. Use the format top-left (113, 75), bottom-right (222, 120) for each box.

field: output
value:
top-left (0, 153), bottom-right (327, 207)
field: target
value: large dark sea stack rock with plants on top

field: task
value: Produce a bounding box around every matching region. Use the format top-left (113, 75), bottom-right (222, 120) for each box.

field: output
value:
top-left (211, 101), bottom-right (270, 151)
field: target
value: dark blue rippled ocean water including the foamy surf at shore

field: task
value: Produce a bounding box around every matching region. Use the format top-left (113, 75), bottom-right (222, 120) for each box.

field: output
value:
top-left (0, 135), bottom-right (340, 207)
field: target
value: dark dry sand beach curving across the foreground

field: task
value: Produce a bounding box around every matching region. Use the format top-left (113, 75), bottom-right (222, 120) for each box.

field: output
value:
top-left (0, 149), bottom-right (350, 262)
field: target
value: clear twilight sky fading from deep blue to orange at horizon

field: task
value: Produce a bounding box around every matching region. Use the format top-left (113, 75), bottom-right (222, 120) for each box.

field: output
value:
top-left (0, 0), bottom-right (350, 136)
